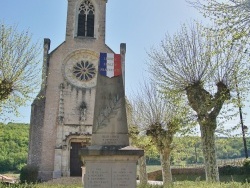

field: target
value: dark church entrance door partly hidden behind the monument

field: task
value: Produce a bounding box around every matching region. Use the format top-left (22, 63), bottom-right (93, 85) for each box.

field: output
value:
top-left (70, 142), bottom-right (82, 176)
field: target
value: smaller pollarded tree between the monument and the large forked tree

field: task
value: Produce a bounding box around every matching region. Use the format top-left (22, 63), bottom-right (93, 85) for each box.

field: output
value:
top-left (131, 83), bottom-right (191, 185)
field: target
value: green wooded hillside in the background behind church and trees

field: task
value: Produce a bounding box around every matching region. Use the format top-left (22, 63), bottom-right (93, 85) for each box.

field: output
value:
top-left (0, 120), bottom-right (250, 172)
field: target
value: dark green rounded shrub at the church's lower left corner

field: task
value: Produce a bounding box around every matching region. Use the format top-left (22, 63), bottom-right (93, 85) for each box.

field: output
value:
top-left (20, 165), bottom-right (38, 183)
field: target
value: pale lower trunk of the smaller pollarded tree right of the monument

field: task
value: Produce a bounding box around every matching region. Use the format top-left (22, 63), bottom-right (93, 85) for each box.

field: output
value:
top-left (160, 148), bottom-right (172, 186)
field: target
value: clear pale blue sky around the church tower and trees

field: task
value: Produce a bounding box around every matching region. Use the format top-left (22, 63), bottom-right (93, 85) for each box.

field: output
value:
top-left (0, 0), bottom-right (250, 135)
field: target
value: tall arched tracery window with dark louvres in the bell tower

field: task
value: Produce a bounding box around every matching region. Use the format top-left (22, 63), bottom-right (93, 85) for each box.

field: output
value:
top-left (77, 0), bottom-right (95, 37)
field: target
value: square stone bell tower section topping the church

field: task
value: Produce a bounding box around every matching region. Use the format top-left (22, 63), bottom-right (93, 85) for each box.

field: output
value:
top-left (66, 0), bottom-right (107, 42)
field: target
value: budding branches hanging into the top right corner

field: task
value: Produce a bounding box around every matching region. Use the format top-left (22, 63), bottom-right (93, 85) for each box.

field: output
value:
top-left (187, 0), bottom-right (250, 39)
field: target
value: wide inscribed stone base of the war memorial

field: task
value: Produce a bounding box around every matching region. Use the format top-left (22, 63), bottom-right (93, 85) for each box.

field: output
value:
top-left (80, 146), bottom-right (144, 188)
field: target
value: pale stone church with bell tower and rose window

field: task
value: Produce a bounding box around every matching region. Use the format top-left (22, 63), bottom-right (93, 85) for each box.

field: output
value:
top-left (28, 0), bottom-right (125, 180)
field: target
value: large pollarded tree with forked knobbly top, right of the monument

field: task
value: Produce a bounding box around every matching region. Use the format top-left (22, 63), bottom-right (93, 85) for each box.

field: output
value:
top-left (148, 24), bottom-right (249, 181)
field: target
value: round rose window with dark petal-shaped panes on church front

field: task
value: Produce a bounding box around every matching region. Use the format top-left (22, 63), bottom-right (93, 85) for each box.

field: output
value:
top-left (73, 61), bottom-right (96, 81)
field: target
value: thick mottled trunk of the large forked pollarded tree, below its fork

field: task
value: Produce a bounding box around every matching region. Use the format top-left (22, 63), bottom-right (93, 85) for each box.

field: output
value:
top-left (200, 119), bottom-right (219, 182)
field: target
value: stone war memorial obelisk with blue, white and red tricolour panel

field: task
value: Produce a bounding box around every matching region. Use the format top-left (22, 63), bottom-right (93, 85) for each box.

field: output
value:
top-left (80, 44), bottom-right (144, 188)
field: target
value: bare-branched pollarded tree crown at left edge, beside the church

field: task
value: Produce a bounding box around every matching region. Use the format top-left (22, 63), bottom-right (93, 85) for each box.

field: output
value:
top-left (0, 24), bottom-right (41, 119)
